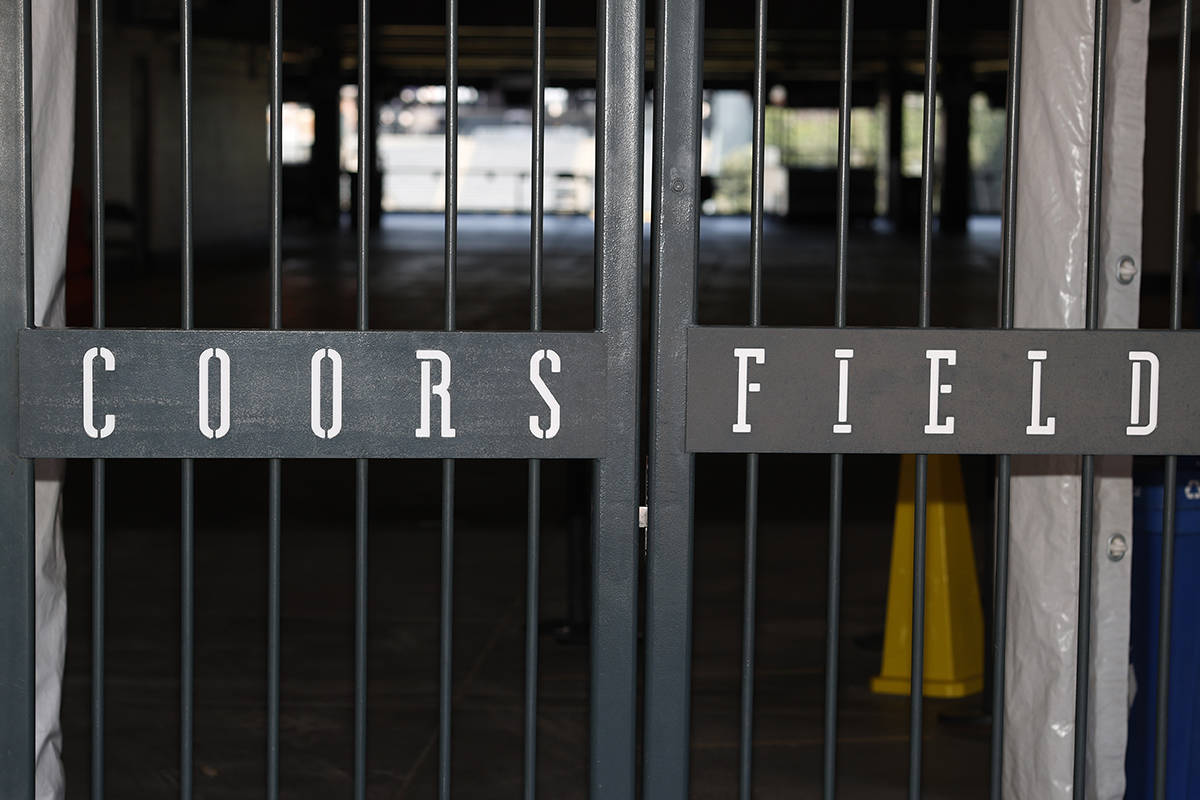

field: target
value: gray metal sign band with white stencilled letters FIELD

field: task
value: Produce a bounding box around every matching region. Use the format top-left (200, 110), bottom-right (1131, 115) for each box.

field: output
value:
top-left (686, 327), bottom-right (1200, 455)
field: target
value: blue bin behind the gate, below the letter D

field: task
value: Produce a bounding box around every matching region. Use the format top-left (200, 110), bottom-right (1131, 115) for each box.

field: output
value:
top-left (1126, 458), bottom-right (1200, 800)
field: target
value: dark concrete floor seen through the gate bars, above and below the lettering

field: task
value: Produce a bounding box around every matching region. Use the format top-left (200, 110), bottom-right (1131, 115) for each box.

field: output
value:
top-left (56, 216), bottom-right (1000, 799)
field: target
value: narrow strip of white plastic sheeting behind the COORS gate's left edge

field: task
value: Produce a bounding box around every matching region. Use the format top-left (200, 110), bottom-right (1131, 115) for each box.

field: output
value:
top-left (30, 0), bottom-right (76, 800)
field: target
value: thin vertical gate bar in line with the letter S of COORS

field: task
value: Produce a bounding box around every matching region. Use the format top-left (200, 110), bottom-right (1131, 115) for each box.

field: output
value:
top-left (524, 0), bottom-right (546, 800)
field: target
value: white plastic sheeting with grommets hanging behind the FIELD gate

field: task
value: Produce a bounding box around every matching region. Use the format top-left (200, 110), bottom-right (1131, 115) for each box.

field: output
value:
top-left (1003, 0), bottom-right (1150, 800)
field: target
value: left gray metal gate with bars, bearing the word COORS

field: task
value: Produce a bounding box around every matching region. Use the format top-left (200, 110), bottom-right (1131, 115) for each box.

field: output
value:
top-left (0, 0), bottom-right (643, 798)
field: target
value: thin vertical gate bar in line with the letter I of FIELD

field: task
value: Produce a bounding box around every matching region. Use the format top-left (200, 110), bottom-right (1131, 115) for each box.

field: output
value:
top-left (822, 0), bottom-right (854, 800)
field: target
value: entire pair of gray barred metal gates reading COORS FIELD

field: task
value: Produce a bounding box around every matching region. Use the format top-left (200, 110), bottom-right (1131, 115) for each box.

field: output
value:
top-left (0, 0), bottom-right (1200, 799)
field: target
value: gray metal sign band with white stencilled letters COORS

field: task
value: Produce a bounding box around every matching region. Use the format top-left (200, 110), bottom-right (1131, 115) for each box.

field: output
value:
top-left (19, 330), bottom-right (606, 458)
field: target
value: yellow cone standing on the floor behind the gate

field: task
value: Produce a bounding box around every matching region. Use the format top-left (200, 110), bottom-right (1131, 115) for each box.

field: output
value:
top-left (871, 455), bottom-right (983, 697)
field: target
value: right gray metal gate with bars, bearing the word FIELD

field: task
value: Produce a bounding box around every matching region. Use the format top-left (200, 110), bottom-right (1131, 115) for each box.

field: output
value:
top-left (643, 0), bottom-right (1200, 800)
